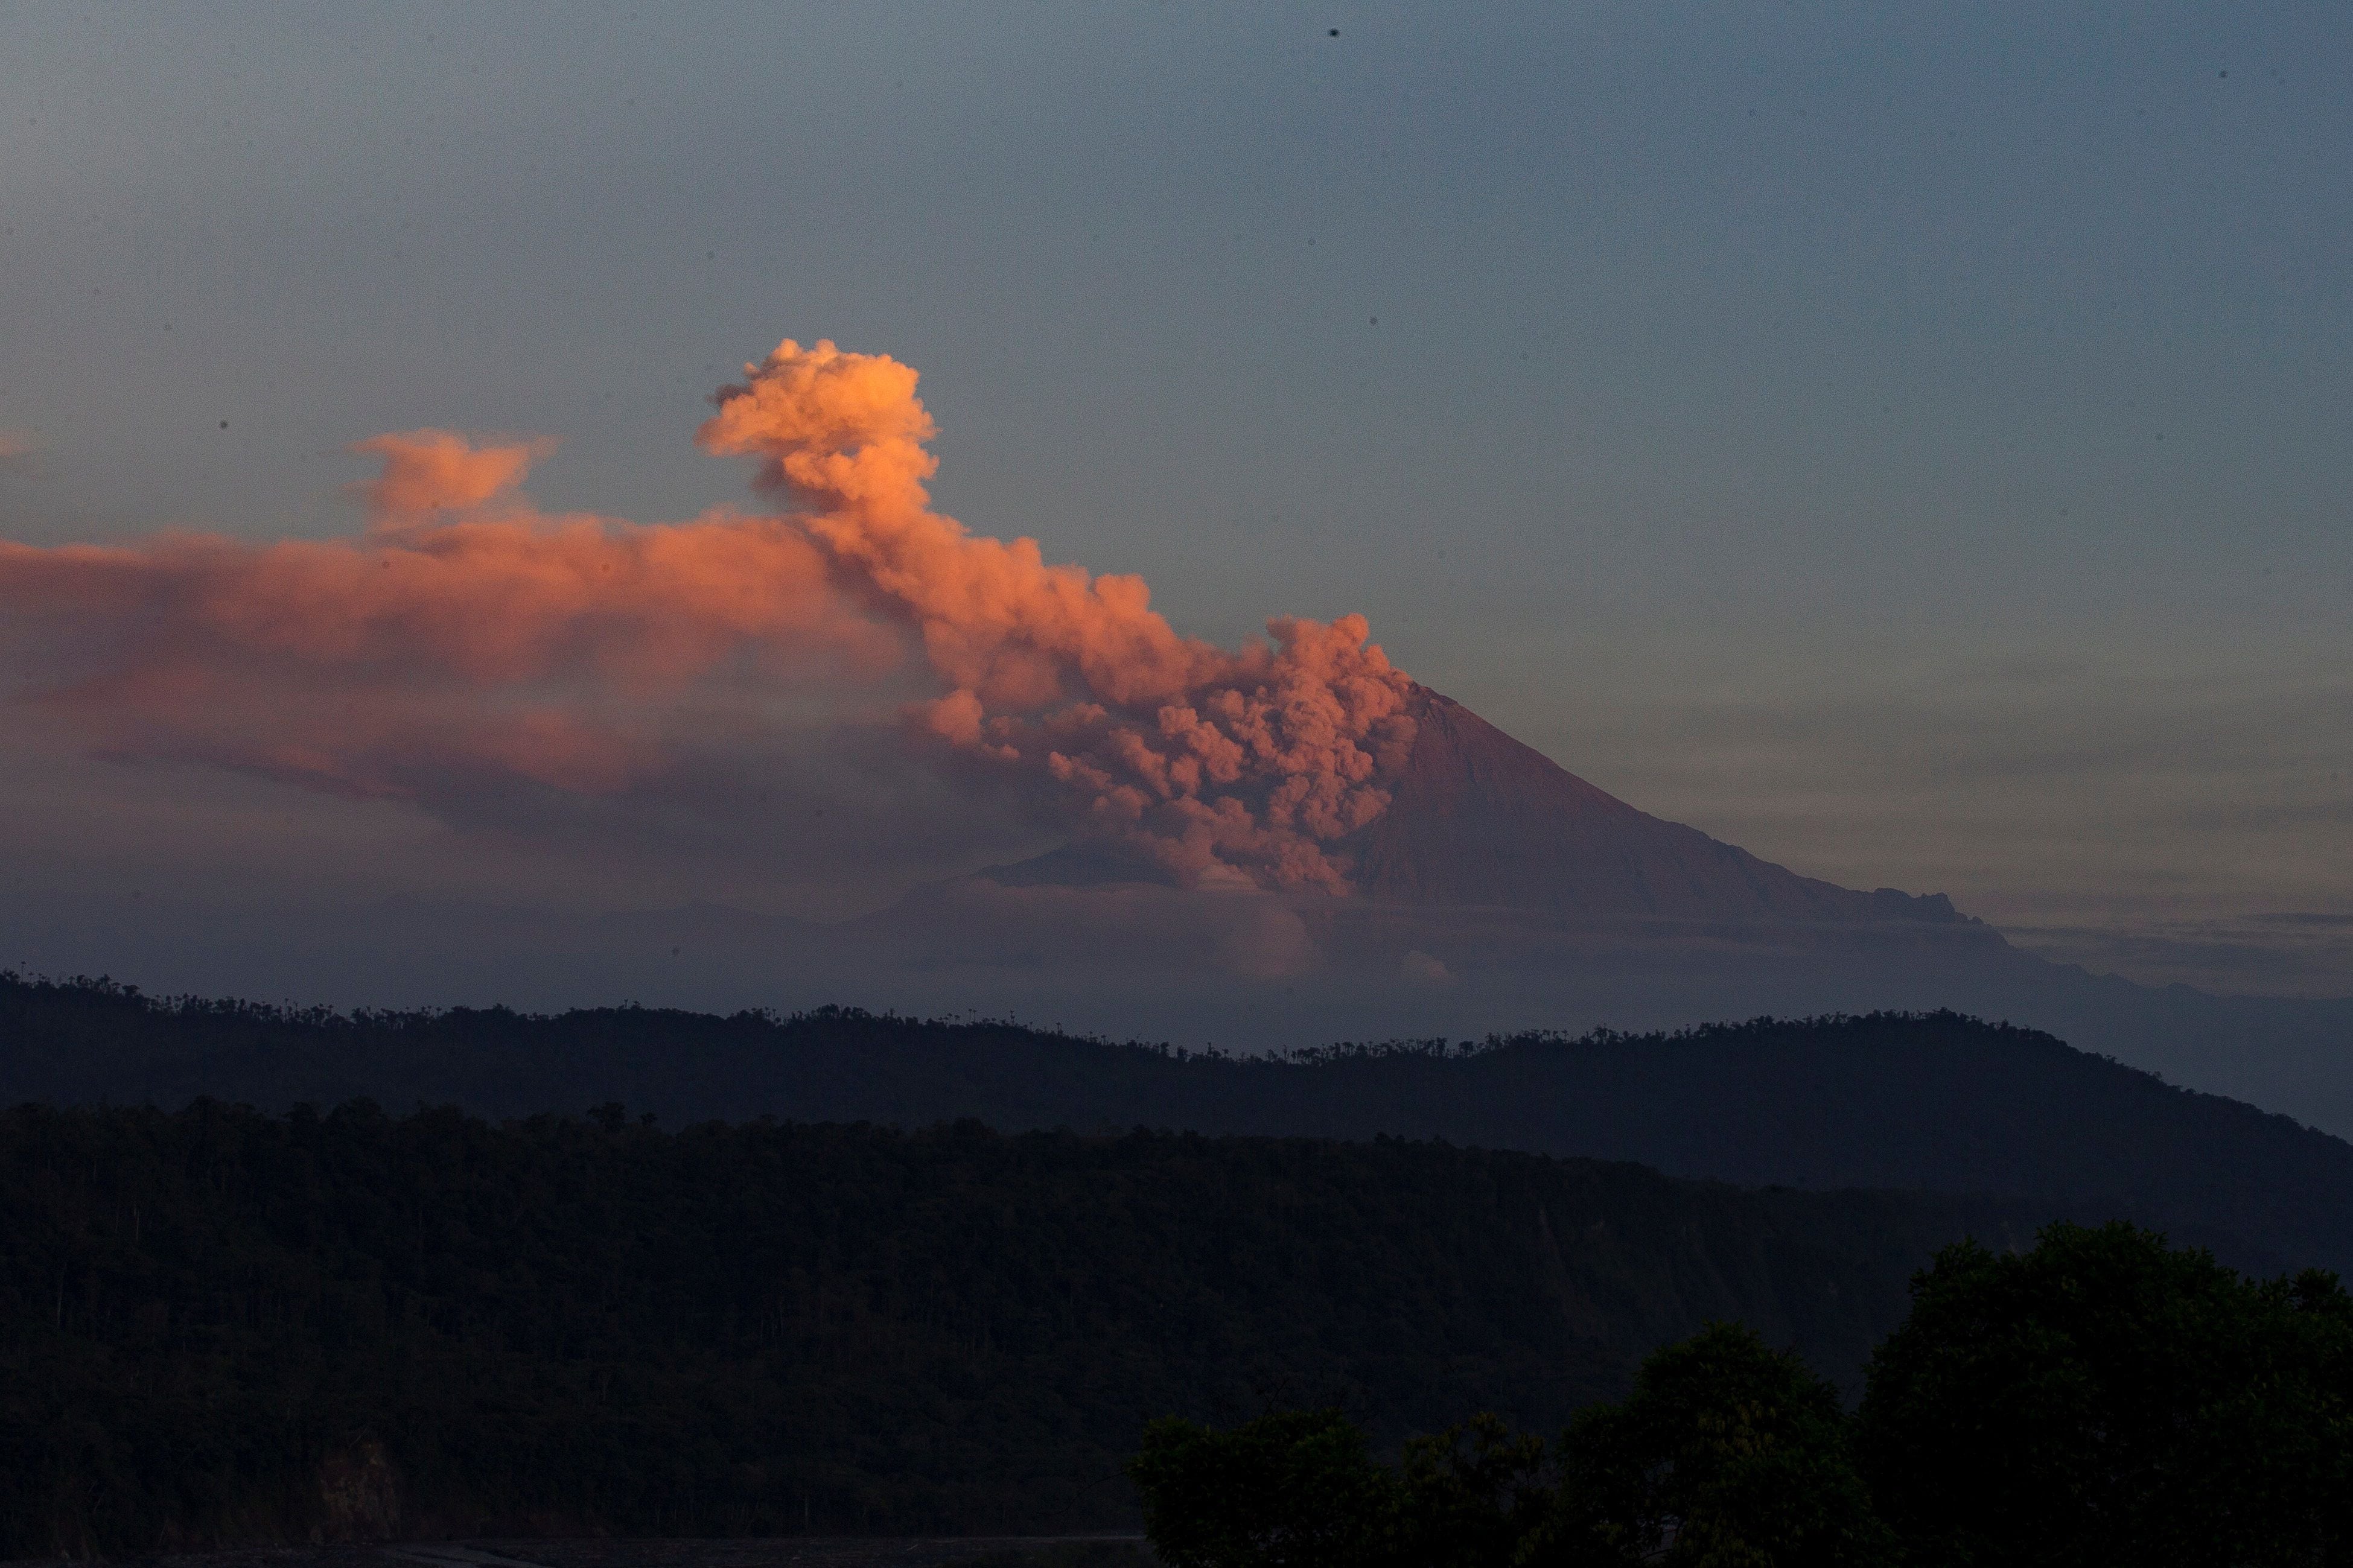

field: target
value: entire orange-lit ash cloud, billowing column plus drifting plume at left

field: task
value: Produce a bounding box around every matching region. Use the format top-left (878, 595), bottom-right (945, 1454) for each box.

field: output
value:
top-left (0, 341), bottom-right (1412, 889)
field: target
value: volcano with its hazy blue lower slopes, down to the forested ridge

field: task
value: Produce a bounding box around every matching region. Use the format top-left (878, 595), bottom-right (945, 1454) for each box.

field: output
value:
top-left (903, 687), bottom-right (2353, 1135)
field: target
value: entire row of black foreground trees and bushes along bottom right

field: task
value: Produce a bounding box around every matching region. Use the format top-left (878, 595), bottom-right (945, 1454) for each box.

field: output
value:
top-left (1130, 1225), bottom-right (2353, 1568)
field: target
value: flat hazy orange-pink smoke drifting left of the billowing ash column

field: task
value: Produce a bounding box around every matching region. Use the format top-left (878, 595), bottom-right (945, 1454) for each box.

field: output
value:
top-left (0, 433), bottom-right (892, 797)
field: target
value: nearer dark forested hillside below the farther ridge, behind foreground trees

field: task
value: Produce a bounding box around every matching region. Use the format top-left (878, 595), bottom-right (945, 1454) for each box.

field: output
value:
top-left (0, 1105), bottom-right (2033, 1557)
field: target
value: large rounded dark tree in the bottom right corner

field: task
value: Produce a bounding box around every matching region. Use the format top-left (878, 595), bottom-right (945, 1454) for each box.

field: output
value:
top-left (1861, 1225), bottom-right (2353, 1568)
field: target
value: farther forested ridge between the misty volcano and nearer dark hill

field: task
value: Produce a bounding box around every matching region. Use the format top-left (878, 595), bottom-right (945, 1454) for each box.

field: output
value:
top-left (0, 978), bottom-right (2353, 1274)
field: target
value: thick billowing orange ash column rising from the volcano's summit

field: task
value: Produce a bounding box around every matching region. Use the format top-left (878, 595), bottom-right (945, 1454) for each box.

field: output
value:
top-left (699, 338), bottom-right (1412, 889)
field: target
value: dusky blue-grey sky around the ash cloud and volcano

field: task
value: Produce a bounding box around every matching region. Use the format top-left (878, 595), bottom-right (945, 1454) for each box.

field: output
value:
top-left (0, 2), bottom-right (2353, 994)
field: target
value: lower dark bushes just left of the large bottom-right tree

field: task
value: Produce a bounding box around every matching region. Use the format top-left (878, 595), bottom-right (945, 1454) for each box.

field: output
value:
top-left (1130, 1324), bottom-right (1894, 1568)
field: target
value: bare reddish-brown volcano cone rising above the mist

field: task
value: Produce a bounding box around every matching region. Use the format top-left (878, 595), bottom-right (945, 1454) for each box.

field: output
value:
top-left (981, 684), bottom-right (1972, 924)
